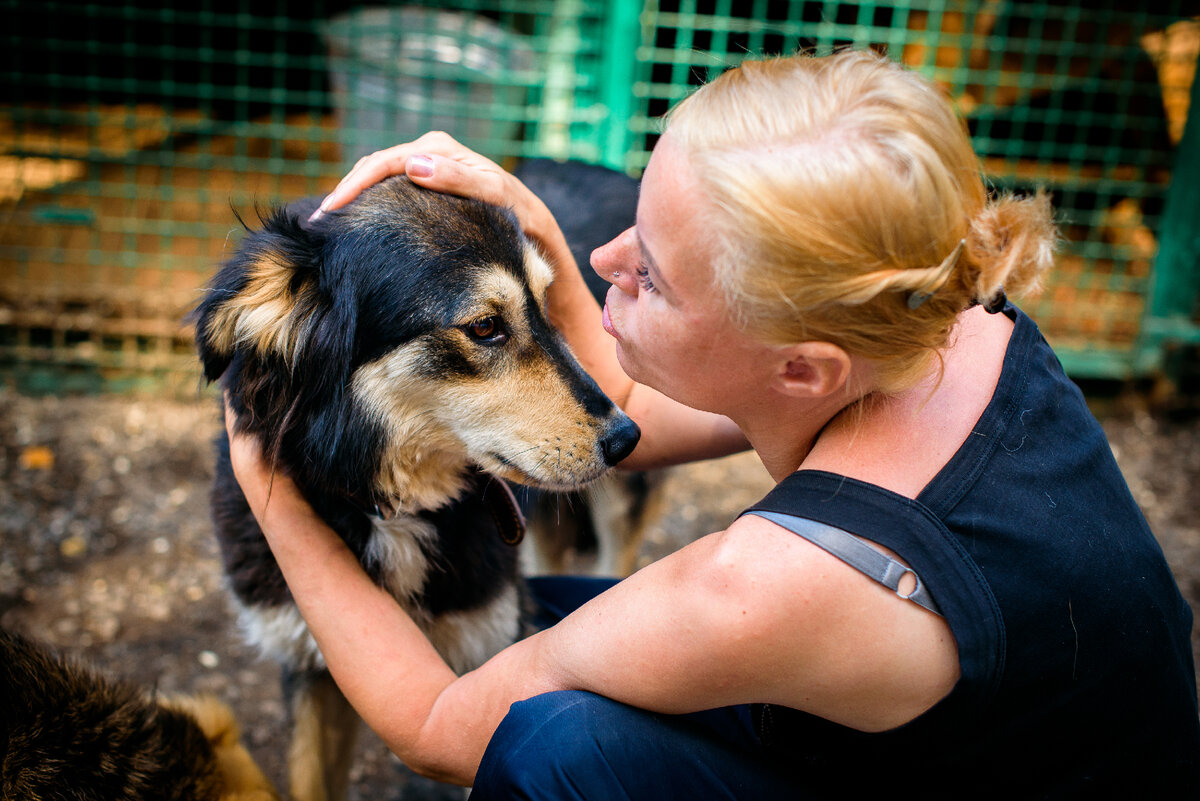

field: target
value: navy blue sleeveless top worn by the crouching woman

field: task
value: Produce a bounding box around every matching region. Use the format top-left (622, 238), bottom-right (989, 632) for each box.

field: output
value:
top-left (751, 306), bottom-right (1200, 799)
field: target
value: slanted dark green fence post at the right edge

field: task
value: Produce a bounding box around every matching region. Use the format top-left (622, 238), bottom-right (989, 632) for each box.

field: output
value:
top-left (1136, 47), bottom-right (1200, 373)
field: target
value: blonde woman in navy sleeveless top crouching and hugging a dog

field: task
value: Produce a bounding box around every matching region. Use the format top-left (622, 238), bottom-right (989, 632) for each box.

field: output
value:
top-left (235, 53), bottom-right (1200, 799)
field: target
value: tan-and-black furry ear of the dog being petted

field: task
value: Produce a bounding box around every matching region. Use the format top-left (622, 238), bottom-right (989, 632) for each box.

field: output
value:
top-left (191, 209), bottom-right (330, 381)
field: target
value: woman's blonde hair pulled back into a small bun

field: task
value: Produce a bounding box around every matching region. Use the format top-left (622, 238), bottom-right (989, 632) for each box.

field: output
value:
top-left (667, 52), bottom-right (1057, 391)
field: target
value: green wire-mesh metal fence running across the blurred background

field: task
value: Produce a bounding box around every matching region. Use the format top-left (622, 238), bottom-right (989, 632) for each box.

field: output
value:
top-left (0, 0), bottom-right (1200, 392)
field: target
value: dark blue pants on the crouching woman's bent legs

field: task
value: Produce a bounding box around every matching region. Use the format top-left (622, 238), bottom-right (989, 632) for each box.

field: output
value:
top-left (470, 577), bottom-right (803, 801)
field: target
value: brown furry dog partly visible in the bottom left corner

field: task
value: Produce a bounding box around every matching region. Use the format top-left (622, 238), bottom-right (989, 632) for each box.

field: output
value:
top-left (0, 630), bottom-right (278, 801)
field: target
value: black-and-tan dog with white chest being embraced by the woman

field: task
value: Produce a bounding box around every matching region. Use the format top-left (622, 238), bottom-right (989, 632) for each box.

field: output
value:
top-left (192, 176), bottom-right (640, 801)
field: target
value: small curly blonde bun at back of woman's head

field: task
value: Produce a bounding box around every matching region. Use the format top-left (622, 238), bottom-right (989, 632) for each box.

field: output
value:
top-left (962, 189), bottom-right (1058, 306)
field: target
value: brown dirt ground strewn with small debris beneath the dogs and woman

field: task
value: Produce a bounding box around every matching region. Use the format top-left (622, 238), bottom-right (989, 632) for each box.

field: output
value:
top-left (0, 389), bottom-right (1200, 801)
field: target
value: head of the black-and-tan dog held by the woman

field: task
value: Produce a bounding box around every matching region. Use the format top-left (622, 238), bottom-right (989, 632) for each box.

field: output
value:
top-left (194, 177), bottom-right (638, 508)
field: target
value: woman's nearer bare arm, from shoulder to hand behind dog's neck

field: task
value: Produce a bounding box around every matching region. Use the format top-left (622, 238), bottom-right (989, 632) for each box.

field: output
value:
top-left (223, 402), bottom-right (958, 784)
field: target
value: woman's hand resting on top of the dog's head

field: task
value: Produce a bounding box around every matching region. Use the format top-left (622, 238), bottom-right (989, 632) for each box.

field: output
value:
top-left (311, 131), bottom-right (558, 243)
